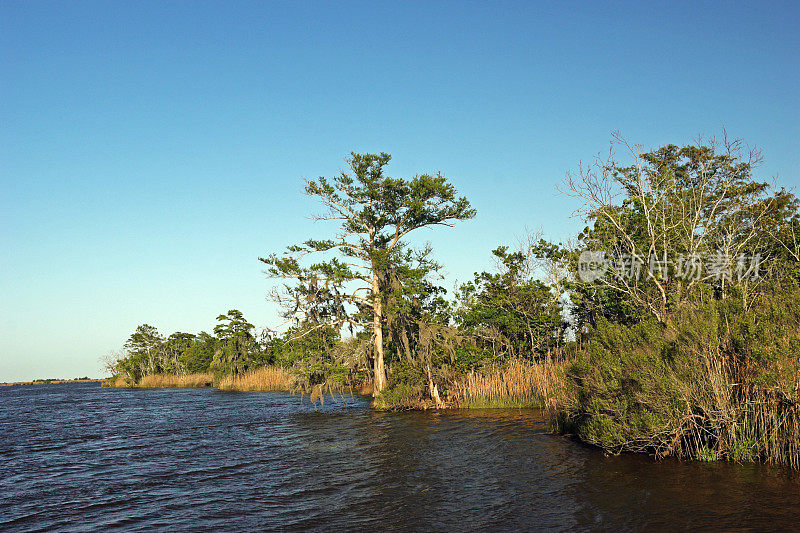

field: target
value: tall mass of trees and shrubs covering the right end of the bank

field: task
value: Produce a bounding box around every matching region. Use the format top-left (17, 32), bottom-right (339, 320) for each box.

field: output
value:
top-left (537, 138), bottom-right (800, 466)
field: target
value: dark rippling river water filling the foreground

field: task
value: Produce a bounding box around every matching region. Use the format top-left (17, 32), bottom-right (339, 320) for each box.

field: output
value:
top-left (0, 383), bottom-right (800, 531)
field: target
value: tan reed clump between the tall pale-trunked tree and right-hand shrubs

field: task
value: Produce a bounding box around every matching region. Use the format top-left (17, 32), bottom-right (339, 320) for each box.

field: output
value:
top-left (448, 357), bottom-right (567, 408)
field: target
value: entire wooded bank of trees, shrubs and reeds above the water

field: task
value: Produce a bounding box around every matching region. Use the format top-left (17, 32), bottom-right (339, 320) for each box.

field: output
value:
top-left (112, 137), bottom-right (800, 466)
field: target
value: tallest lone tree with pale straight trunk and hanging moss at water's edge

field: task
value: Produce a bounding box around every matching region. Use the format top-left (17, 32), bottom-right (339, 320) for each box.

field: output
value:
top-left (260, 153), bottom-right (475, 393)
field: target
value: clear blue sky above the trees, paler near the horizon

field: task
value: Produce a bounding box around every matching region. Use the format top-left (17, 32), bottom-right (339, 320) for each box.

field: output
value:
top-left (0, 0), bottom-right (800, 381)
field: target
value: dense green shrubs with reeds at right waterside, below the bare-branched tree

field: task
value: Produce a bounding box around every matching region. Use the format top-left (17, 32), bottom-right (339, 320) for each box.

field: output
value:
top-left (560, 289), bottom-right (800, 463)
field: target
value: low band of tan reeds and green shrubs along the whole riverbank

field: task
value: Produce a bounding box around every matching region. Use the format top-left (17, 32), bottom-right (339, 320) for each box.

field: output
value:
top-left (106, 324), bottom-right (800, 469)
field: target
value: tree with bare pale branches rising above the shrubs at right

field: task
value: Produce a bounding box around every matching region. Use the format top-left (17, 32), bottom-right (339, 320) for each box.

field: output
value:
top-left (564, 135), bottom-right (785, 324)
